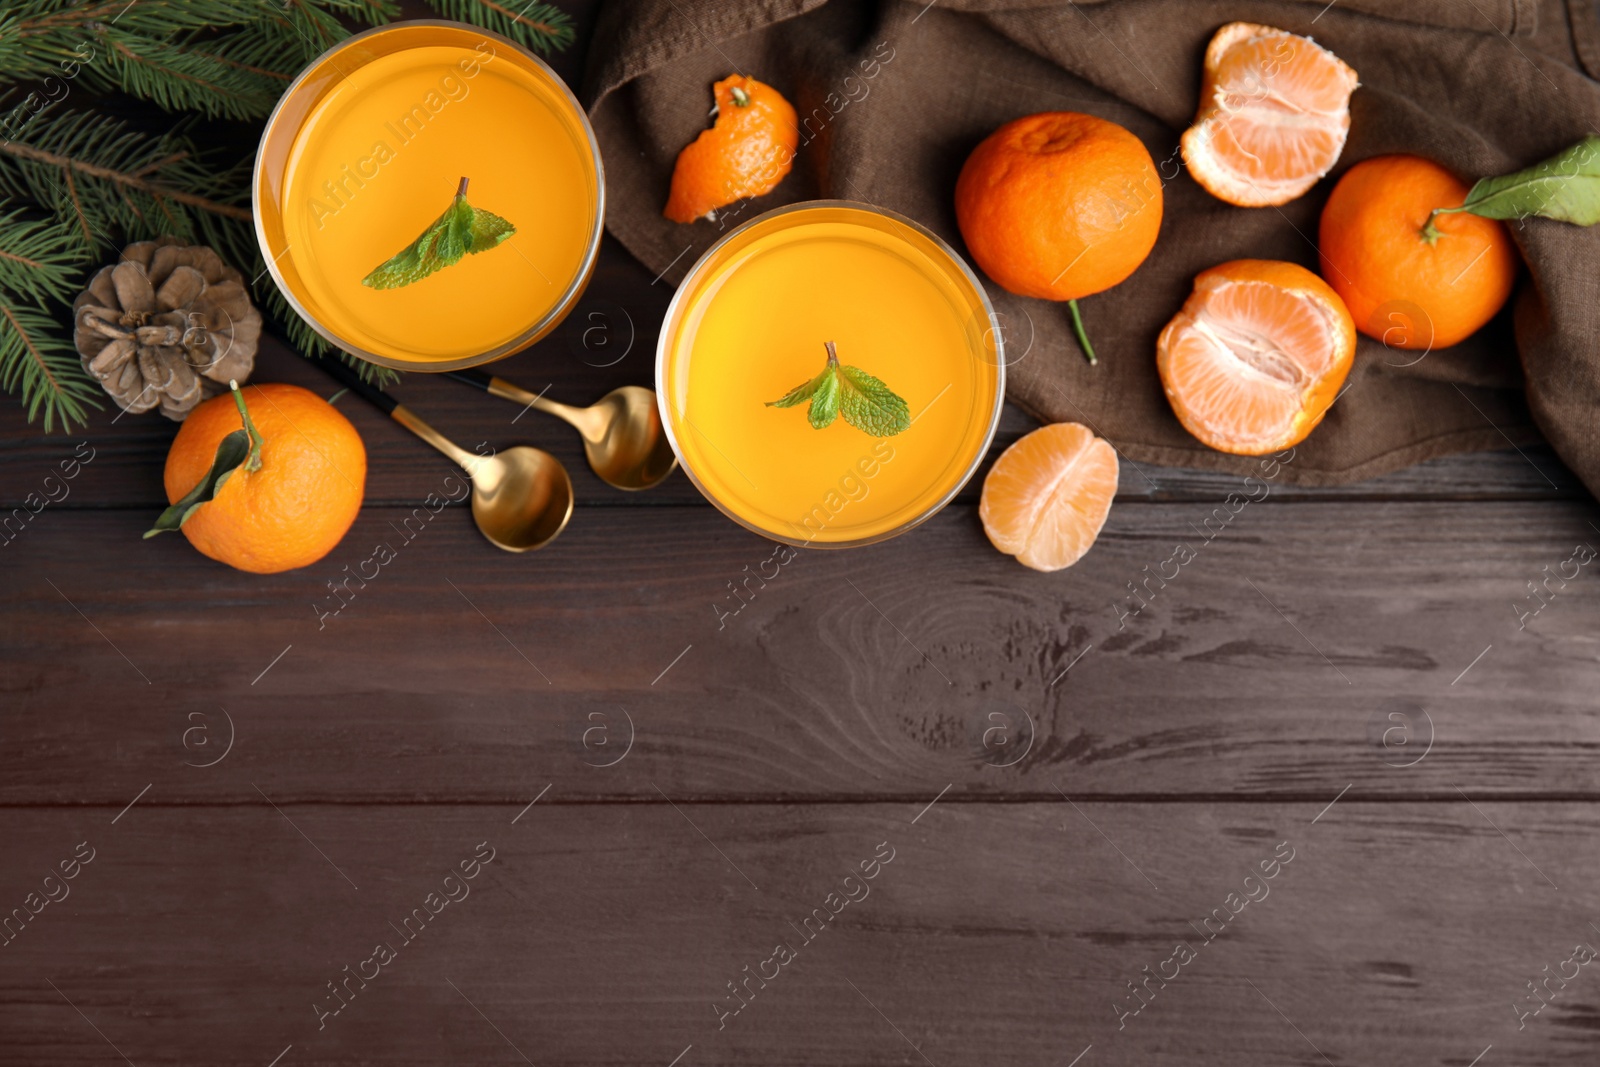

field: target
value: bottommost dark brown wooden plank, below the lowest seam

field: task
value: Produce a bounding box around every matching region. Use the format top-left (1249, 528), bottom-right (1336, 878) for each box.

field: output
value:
top-left (0, 799), bottom-right (1600, 1067)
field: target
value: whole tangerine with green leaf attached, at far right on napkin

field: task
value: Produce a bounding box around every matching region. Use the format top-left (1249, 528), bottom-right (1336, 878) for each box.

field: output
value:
top-left (1317, 155), bottom-right (1517, 349)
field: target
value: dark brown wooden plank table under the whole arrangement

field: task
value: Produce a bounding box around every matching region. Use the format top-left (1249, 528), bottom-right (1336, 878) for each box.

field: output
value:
top-left (0, 4), bottom-right (1600, 1067)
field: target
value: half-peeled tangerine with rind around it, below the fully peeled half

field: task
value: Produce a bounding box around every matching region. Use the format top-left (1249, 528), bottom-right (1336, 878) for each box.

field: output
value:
top-left (1155, 259), bottom-right (1355, 456)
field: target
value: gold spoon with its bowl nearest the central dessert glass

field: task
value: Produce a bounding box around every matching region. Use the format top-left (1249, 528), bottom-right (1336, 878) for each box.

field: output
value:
top-left (446, 370), bottom-right (678, 490)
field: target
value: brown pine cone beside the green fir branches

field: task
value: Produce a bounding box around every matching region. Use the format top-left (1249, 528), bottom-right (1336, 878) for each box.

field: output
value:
top-left (72, 237), bottom-right (261, 422)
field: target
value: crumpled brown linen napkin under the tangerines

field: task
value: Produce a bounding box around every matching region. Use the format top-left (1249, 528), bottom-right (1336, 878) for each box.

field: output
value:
top-left (586, 0), bottom-right (1600, 493)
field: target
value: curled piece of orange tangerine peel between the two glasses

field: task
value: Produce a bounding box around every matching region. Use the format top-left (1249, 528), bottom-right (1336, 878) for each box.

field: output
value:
top-left (662, 74), bottom-right (800, 222)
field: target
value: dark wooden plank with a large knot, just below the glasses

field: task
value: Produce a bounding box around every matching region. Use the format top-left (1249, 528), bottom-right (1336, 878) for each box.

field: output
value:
top-left (0, 498), bottom-right (1600, 803)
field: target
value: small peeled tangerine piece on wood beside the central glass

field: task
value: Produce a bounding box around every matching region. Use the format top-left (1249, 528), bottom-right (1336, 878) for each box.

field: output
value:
top-left (978, 422), bottom-right (1117, 571)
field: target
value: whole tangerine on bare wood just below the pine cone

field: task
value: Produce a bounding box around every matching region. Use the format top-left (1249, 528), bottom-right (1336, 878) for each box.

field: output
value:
top-left (162, 384), bottom-right (366, 574)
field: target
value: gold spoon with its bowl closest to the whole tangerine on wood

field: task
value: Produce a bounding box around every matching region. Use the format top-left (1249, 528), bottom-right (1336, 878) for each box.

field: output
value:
top-left (315, 358), bottom-right (573, 552)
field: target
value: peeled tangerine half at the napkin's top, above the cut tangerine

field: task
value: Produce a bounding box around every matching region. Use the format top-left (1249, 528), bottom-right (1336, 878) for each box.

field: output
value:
top-left (1182, 22), bottom-right (1358, 208)
